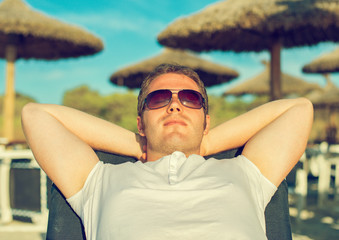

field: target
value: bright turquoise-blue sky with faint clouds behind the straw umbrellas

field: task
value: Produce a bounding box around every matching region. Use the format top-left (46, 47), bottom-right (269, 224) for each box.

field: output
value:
top-left (0, 0), bottom-right (339, 104)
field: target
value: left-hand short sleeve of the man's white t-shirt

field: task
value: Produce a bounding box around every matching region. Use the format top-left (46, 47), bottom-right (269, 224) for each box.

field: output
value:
top-left (67, 161), bottom-right (104, 218)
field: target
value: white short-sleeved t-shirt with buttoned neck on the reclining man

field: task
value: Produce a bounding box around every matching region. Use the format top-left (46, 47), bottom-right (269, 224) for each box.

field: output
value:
top-left (68, 152), bottom-right (277, 240)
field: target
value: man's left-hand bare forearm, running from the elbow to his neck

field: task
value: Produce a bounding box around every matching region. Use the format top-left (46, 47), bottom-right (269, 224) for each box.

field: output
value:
top-left (23, 104), bottom-right (142, 158)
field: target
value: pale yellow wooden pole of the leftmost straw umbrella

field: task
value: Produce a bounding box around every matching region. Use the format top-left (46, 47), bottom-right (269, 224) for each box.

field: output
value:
top-left (3, 45), bottom-right (16, 142)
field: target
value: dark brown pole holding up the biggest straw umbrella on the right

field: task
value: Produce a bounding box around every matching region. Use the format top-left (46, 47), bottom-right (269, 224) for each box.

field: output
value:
top-left (270, 39), bottom-right (282, 100)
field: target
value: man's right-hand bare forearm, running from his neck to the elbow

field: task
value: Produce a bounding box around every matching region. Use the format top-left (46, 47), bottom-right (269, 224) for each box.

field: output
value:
top-left (203, 98), bottom-right (309, 155)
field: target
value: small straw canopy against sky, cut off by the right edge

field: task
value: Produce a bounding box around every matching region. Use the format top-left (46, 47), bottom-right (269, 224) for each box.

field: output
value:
top-left (302, 48), bottom-right (339, 74)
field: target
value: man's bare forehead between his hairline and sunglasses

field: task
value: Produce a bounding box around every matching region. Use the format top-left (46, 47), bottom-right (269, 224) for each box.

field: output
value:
top-left (148, 73), bottom-right (200, 92)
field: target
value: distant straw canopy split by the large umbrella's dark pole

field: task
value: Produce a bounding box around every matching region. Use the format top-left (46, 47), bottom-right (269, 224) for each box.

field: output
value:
top-left (224, 62), bottom-right (321, 96)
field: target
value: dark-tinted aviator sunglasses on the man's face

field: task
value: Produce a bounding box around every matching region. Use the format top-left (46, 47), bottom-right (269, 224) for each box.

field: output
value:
top-left (144, 89), bottom-right (205, 110)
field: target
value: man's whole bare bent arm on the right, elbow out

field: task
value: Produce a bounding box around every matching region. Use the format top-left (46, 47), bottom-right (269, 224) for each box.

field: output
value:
top-left (201, 98), bottom-right (313, 186)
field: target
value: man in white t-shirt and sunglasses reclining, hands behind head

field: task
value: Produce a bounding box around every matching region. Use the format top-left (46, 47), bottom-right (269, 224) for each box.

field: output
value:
top-left (22, 64), bottom-right (313, 239)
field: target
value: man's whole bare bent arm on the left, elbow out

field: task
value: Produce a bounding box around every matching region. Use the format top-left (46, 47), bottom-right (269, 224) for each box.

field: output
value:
top-left (22, 103), bottom-right (142, 198)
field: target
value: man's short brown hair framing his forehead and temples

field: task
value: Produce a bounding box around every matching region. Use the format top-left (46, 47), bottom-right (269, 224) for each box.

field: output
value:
top-left (138, 63), bottom-right (208, 117)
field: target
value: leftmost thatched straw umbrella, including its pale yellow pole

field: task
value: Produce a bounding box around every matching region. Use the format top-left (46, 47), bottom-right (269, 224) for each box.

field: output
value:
top-left (0, 0), bottom-right (103, 140)
